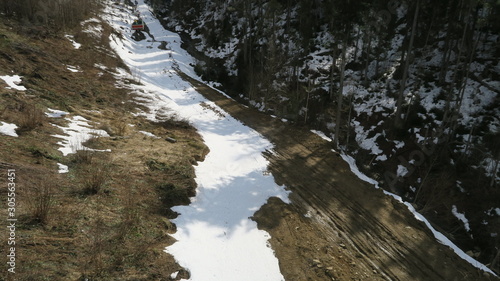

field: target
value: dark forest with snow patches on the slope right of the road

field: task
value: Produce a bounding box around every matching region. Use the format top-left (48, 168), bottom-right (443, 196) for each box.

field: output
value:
top-left (149, 0), bottom-right (500, 272)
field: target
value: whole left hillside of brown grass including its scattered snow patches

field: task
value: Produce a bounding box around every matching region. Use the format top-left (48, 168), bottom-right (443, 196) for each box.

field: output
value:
top-left (0, 1), bottom-right (207, 281)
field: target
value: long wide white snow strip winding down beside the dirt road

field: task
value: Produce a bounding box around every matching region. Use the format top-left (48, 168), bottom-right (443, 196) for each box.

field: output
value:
top-left (106, 1), bottom-right (288, 281)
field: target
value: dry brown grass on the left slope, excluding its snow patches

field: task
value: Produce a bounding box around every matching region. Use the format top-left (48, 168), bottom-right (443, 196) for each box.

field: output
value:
top-left (0, 6), bottom-right (207, 280)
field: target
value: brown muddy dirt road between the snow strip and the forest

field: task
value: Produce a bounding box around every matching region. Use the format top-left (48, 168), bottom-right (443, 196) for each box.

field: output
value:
top-left (181, 74), bottom-right (500, 281)
